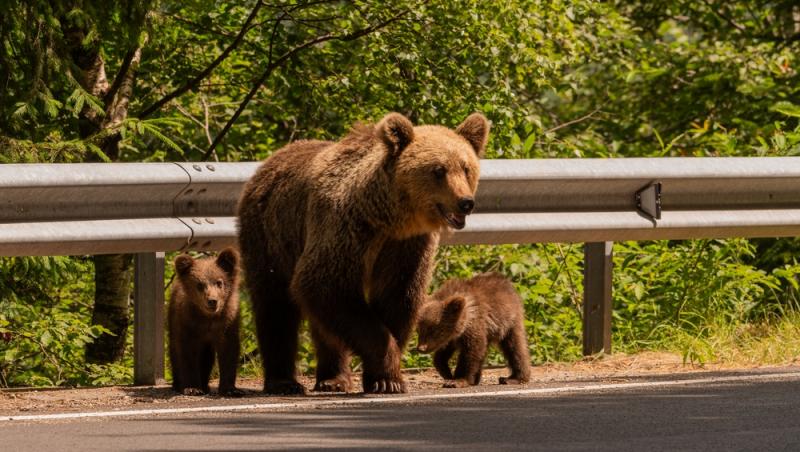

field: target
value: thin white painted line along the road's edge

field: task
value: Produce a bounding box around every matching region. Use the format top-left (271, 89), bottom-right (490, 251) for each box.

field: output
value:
top-left (6, 372), bottom-right (800, 422)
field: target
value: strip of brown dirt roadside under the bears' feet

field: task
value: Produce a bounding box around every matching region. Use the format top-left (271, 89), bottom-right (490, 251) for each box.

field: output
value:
top-left (0, 352), bottom-right (788, 416)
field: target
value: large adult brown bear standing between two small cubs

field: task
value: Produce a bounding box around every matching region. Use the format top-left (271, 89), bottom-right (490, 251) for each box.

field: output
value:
top-left (238, 113), bottom-right (489, 394)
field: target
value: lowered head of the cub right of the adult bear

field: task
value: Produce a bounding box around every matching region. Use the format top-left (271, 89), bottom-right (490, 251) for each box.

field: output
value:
top-left (417, 295), bottom-right (475, 353)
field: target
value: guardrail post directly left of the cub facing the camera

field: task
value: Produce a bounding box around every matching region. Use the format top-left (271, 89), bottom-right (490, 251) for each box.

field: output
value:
top-left (133, 252), bottom-right (164, 385)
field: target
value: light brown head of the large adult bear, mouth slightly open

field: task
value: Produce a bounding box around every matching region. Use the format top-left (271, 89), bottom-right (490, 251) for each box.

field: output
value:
top-left (376, 113), bottom-right (490, 236)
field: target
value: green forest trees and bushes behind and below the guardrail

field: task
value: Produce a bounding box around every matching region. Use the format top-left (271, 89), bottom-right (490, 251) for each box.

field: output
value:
top-left (0, 0), bottom-right (800, 386)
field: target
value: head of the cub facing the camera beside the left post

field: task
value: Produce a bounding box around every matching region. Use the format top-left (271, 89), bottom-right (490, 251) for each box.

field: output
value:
top-left (175, 248), bottom-right (239, 316)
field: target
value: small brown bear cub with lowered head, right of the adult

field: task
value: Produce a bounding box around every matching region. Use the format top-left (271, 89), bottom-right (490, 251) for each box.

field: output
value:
top-left (417, 273), bottom-right (530, 387)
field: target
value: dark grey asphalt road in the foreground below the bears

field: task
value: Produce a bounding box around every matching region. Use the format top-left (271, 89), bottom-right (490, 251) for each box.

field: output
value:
top-left (0, 374), bottom-right (800, 451)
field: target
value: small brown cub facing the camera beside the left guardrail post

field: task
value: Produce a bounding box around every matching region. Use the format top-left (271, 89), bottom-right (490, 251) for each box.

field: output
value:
top-left (167, 248), bottom-right (242, 396)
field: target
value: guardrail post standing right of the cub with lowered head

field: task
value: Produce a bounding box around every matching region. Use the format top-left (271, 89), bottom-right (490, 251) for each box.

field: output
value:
top-left (583, 242), bottom-right (614, 356)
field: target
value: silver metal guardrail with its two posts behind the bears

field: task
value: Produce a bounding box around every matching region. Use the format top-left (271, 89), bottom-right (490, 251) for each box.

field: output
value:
top-left (0, 157), bottom-right (800, 383)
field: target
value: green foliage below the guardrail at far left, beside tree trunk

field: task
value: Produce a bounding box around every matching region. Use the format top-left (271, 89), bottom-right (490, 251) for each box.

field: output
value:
top-left (0, 257), bottom-right (132, 386)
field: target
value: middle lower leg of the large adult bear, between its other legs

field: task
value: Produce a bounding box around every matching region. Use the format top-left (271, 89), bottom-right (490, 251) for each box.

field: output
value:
top-left (311, 325), bottom-right (351, 392)
